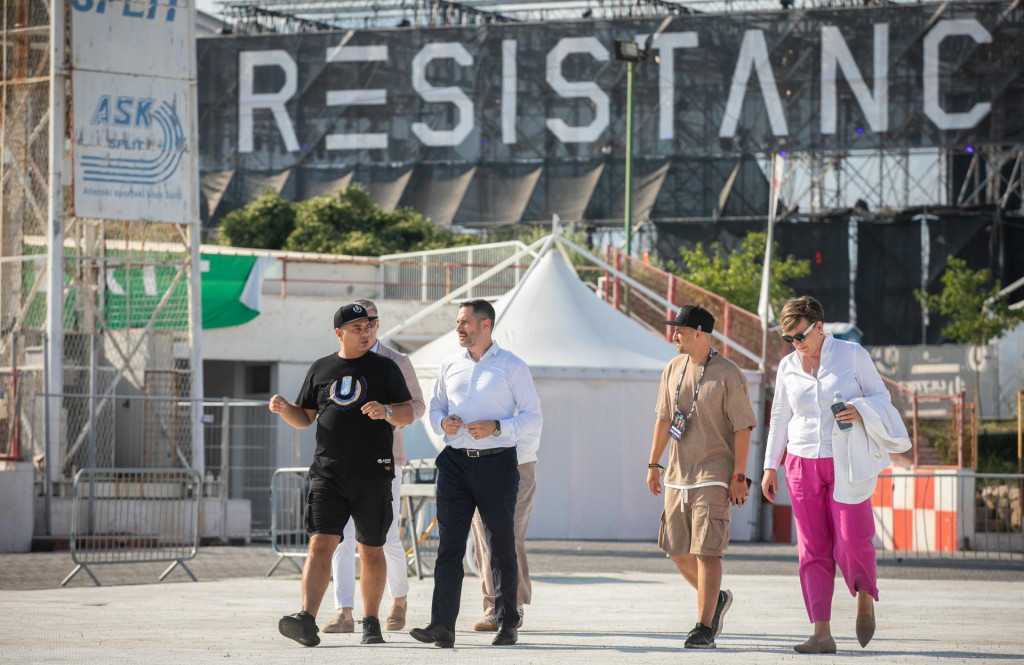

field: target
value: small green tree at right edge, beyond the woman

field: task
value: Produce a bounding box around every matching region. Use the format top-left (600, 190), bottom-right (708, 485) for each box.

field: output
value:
top-left (913, 256), bottom-right (1024, 345)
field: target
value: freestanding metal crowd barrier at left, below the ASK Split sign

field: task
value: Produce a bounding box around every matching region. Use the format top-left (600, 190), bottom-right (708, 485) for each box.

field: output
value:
top-left (60, 468), bottom-right (203, 586)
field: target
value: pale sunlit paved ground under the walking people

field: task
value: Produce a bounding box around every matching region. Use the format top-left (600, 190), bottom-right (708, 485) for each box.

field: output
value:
top-left (0, 541), bottom-right (1024, 665)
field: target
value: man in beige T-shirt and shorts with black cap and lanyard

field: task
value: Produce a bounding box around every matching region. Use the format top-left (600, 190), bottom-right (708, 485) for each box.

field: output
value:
top-left (647, 305), bottom-right (757, 649)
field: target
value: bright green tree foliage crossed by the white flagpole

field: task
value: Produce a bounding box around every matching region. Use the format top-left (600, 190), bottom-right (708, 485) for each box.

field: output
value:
top-left (671, 233), bottom-right (811, 311)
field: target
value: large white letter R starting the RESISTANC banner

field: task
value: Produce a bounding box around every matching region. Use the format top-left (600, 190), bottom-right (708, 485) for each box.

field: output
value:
top-left (239, 50), bottom-right (299, 153)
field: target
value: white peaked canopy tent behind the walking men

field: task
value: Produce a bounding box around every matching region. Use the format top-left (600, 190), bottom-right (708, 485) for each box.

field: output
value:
top-left (404, 243), bottom-right (755, 540)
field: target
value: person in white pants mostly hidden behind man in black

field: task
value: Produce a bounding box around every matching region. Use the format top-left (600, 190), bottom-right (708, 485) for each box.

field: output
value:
top-left (324, 300), bottom-right (426, 632)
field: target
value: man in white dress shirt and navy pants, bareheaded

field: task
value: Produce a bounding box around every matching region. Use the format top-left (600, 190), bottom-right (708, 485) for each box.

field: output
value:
top-left (410, 300), bottom-right (543, 648)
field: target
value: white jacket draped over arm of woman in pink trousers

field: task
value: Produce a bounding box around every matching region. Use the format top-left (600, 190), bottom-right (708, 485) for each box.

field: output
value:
top-left (833, 392), bottom-right (911, 503)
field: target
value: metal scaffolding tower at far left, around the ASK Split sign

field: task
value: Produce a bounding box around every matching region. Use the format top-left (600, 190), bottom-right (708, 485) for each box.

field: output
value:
top-left (0, 0), bottom-right (202, 514)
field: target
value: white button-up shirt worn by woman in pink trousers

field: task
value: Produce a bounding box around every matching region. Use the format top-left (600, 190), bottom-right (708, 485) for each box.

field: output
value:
top-left (764, 335), bottom-right (889, 469)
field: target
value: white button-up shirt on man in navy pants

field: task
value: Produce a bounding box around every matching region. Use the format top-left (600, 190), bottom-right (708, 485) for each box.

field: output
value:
top-left (430, 342), bottom-right (543, 464)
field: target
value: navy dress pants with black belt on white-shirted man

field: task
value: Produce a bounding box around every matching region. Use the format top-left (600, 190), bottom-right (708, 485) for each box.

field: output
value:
top-left (430, 447), bottom-right (519, 631)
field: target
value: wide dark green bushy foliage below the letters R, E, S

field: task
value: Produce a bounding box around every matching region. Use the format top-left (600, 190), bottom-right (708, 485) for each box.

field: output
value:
top-left (220, 184), bottom-right (476, 256)
